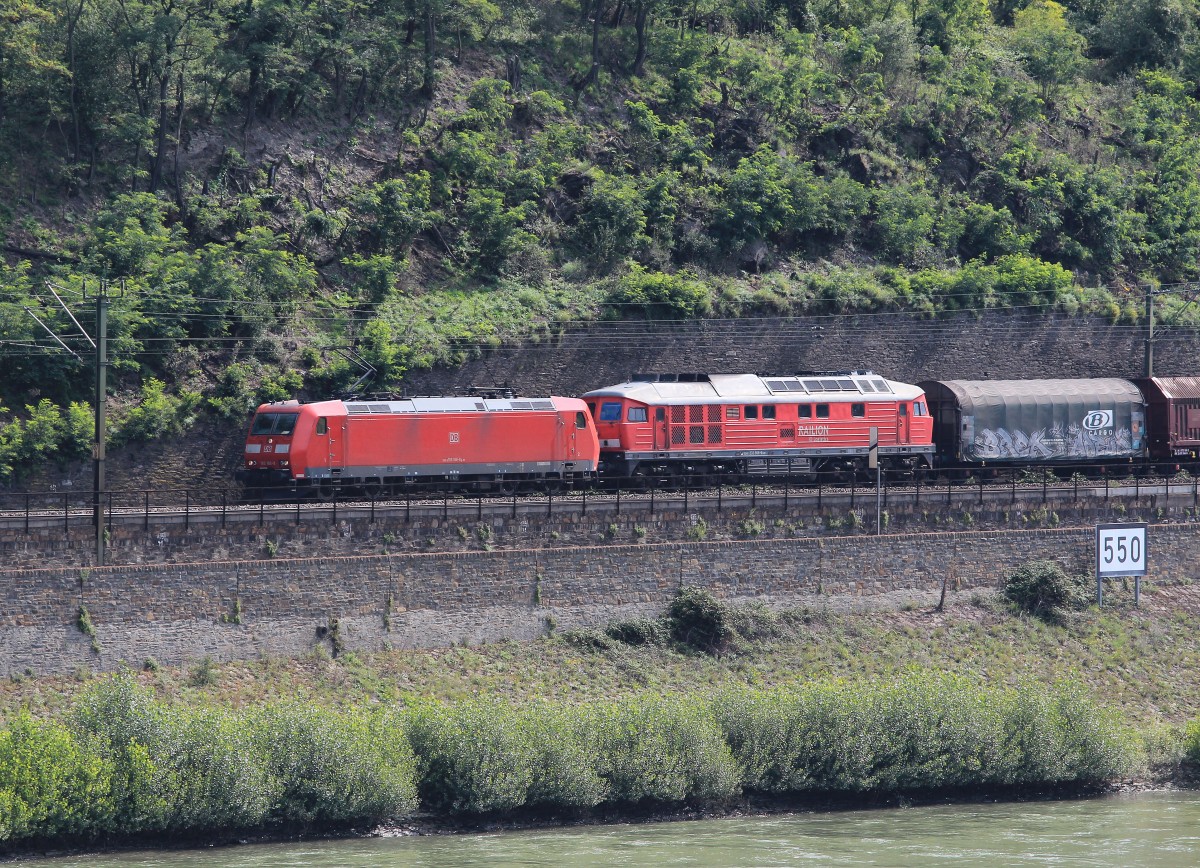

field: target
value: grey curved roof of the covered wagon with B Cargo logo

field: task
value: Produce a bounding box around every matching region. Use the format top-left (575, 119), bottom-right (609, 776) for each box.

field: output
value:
top-left (919, 377), bottom-right (1142, 412)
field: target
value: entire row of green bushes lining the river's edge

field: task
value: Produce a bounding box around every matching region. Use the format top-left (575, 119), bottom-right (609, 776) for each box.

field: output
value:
top-left (0, 672), bottom-right (1138, 846)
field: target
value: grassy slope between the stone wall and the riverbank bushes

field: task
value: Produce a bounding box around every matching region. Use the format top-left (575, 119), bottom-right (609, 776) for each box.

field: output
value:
top-left (0, 587), bottom-right (1200, 730)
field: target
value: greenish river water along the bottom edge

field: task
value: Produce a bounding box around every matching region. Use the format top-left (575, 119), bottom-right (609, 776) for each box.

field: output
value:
top-left (21, 792), bottom-right (1200, 868)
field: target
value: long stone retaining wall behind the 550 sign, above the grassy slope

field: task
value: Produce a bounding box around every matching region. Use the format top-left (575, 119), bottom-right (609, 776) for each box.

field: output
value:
top-left (0, 525), bottom-right (1200, 676)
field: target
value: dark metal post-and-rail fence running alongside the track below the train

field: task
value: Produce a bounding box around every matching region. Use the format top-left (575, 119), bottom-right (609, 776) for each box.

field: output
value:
top-left (0, 465), bottom-right (1200, 538)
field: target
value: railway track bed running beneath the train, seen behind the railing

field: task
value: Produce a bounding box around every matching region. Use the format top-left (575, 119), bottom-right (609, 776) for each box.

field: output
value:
top-left (0, 474), bottom-right (1200, 537)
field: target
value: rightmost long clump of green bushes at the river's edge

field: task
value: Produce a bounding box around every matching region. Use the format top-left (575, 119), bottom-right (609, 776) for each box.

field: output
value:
top-left (716, 675), bottom-right (1130, 794)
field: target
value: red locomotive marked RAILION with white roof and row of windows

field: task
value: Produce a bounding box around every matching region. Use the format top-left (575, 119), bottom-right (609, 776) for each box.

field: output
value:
top-left (583, 371), bottom-right (934, 475)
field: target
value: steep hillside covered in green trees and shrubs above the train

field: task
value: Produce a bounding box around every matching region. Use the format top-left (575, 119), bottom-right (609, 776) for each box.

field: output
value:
top-left (0, 0), bottom-right (1200, 484)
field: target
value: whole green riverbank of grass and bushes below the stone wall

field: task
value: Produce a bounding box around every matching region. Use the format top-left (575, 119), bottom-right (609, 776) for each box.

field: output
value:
top-left (7, 586), bottom-right (1200, 850)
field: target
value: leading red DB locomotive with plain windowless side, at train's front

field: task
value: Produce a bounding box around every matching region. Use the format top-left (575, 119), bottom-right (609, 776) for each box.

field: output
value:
top-left (242, 396), bottom-right (600, 495)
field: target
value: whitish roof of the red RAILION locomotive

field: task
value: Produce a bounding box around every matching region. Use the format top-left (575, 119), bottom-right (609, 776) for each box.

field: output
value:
top-left (584, 372), bottom-right (920, 403)
